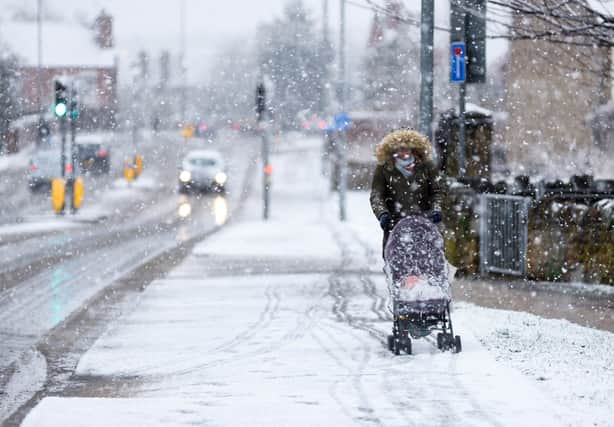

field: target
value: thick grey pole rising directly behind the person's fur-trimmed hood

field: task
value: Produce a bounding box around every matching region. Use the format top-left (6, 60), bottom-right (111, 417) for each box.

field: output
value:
top-left (420, 0), bottom-right (435, 144)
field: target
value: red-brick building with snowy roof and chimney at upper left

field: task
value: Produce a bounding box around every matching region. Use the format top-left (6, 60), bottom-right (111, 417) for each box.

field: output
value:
top-left (0, 11), bottom-right (118, 128)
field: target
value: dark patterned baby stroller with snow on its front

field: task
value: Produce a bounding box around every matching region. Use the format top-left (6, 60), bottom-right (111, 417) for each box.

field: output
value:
top-left (384, 215), bottom-right (461, 355)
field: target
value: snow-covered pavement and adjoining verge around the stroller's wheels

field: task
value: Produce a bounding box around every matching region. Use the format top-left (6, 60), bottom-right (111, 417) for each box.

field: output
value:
top-left (23, 135), bottom-right (614, 426)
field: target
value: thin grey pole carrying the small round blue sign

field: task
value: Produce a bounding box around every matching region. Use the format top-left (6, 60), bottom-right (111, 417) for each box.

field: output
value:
top-left (335, 0), bottom-right (347, 221)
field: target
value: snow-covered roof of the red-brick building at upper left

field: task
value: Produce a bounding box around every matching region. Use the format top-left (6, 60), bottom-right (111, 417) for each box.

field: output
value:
top-left (0, 21), bottom-right (115, 68)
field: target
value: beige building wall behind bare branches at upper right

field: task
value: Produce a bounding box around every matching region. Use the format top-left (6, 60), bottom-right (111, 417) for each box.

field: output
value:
top-left (502, 18), bottom-right (611, 178)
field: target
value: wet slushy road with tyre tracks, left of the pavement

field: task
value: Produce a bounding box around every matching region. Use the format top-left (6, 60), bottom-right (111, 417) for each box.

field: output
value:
top-left (0, 130), bottom-right (260, 419)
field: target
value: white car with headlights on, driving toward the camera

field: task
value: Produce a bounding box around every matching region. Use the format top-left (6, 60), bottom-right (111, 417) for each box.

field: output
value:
top-left (179, 150), bottom-right (228, 194)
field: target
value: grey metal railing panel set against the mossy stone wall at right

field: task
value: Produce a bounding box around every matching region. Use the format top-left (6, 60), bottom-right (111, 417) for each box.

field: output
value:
top-left (480, 194), bottom-right (531, 276)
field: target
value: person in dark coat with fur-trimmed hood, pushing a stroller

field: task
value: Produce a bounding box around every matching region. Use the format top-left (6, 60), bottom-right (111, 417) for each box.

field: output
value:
top-left (370, 129), bottom-right (442, 260)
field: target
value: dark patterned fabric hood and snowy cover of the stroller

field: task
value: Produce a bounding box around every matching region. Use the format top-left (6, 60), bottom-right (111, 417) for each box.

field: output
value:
top-left (384, 215), bottom-right (451, 304)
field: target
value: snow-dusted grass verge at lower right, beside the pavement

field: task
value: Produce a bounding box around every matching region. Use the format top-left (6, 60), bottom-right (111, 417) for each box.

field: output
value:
top-left (454, 303), bottom-right (614, 425)
